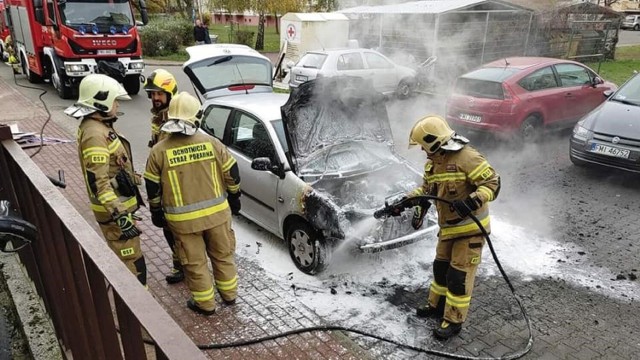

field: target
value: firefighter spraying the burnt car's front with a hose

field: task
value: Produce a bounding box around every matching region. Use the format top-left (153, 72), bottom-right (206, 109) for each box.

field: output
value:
top-left (409, 115), bottom-right (500, 339)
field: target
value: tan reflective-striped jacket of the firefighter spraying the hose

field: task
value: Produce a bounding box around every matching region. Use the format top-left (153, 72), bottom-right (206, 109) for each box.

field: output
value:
top-left (410, 145), bottom-right (500, 240)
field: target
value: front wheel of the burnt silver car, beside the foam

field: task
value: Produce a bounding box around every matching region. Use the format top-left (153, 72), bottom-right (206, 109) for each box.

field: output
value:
top-left (286, 221), bottom-right (331, 275)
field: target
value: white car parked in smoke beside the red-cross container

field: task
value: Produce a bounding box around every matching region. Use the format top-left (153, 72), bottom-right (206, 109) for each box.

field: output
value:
top-left (289, 49), bottom-right (416, 98)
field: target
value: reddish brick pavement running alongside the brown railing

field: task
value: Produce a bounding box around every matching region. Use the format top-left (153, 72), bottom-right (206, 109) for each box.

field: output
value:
top-left (0, 71), bottom-right (368, 359)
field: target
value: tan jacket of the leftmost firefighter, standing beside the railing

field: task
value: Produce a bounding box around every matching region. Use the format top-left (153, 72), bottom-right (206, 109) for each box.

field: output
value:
top-left (76, 113), bottom-right (139, 224)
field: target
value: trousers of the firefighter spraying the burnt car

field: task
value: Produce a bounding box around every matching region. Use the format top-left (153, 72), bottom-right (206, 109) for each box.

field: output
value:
top-left (429, 235), bottom-right (485, 324)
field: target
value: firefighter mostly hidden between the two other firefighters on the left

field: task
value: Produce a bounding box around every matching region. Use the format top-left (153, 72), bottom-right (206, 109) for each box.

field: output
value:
top-left (144, 69), bottom-right (184, 284)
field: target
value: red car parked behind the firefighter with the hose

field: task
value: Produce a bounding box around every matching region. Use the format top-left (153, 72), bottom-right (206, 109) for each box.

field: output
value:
top-left (446, 57), bottom-right (617, 141)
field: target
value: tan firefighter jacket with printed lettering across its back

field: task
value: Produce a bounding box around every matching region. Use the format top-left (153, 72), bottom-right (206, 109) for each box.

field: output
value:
top-left (144, 131), bottom-right (240, 234)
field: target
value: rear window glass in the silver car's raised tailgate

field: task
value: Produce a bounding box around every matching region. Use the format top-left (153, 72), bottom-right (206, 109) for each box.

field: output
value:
top-left (190, 55), bottom-right (271, 93)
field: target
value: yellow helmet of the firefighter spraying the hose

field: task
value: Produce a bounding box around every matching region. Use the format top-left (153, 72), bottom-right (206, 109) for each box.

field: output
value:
top-left (409, 115), bottom-right (459, 154)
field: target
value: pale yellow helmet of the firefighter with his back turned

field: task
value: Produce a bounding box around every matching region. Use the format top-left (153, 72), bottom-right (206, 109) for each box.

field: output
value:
top-left (160, 91), bottom-right (202, 135)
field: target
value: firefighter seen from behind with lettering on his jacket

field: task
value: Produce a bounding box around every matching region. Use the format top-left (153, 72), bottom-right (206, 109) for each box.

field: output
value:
top-left (144, 92), bottom-right (240, 315)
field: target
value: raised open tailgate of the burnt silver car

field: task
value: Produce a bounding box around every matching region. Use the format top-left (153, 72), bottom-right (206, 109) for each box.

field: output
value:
top-left (182, 44), bottom-right (273, 99)
